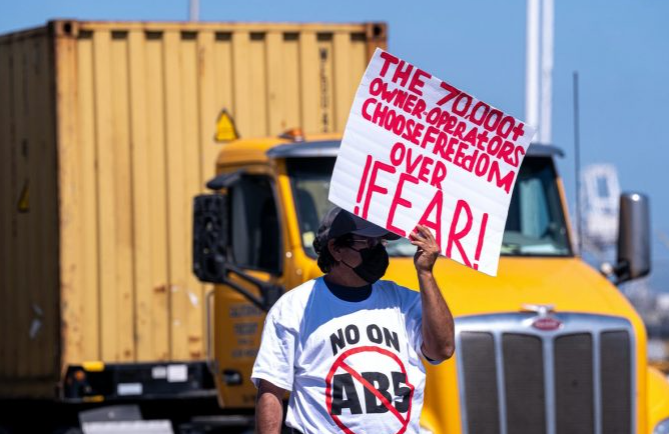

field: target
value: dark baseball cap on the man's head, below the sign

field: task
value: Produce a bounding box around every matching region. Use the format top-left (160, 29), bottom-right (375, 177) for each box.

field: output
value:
top-left (314, 206), bottom-right (400, 252)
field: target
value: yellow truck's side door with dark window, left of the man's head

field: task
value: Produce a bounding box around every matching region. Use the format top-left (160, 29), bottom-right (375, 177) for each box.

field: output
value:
top-left (194, 174), bottom-right (284, 408)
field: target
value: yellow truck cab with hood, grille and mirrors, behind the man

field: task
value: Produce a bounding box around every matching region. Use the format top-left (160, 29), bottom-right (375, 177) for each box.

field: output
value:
top-left (193, 134), bottom-right (669, 434)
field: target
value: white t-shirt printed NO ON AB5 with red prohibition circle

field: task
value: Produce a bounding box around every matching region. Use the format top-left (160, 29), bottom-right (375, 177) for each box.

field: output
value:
top-left (251, 278), bottom-right (425, 434)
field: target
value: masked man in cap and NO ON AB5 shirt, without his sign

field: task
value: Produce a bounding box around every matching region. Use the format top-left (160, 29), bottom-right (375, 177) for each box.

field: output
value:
top-left (252, 208), bottom-right (454, 434)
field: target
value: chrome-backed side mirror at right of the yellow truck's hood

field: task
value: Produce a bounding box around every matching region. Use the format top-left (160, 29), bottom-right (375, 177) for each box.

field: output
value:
top-left (614, 193), bottom-right (650, 283)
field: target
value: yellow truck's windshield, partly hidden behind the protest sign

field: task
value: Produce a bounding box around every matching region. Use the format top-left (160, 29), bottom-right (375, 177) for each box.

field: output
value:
top-left (286, 157), bottom-right (571, 257)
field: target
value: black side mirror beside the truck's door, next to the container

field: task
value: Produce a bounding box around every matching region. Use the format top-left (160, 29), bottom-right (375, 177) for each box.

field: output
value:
top-left (193, 194), bottom-right (228, 283)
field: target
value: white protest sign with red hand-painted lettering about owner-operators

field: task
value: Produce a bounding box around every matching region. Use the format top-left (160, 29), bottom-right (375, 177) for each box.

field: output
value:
top-left (329, 49), bottom-right (535, 276)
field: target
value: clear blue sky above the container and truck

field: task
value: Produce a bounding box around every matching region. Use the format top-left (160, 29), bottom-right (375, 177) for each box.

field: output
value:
top-left (0, 0), bottom-right (669, 260)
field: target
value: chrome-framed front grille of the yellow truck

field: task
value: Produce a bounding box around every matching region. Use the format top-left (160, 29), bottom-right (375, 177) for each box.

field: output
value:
top-left (456, 313), bottom-right (636, 434)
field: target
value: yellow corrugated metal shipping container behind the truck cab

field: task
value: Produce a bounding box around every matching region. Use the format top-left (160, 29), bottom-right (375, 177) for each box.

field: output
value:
top-left (0, 21), bottom-right (386, 397)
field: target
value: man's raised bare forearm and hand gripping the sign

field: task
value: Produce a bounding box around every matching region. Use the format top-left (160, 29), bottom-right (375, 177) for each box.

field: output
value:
top-left (411, 225), bottom-right (455, 362)
